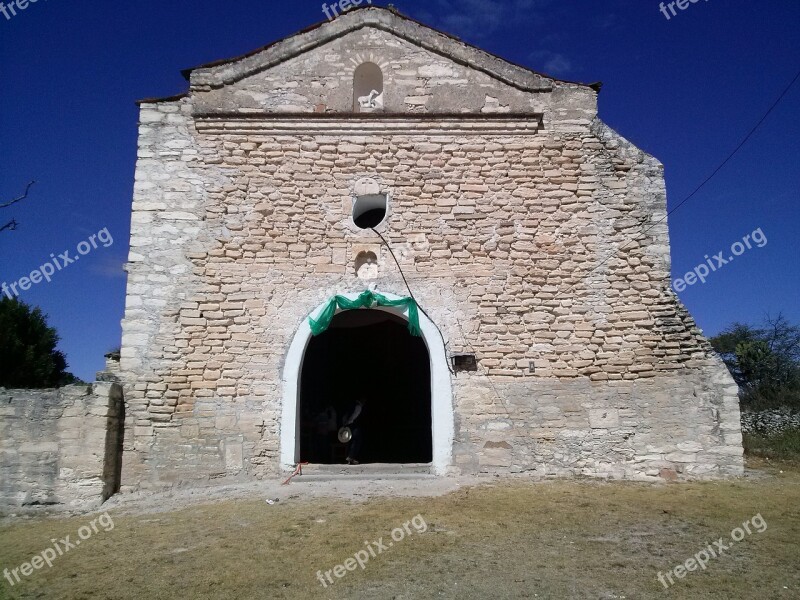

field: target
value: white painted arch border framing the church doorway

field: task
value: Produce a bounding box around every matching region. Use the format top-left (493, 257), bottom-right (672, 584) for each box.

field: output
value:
top-left (280, 292), bottom-right (453, 475)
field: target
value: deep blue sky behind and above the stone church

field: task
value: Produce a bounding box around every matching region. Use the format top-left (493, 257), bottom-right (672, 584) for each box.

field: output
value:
top-left (0, 0), bottom-right (800, 379)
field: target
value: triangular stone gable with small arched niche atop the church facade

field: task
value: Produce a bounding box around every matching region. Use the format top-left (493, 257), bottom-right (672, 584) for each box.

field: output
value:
top-left (180, 7), bottom-right (591, 115)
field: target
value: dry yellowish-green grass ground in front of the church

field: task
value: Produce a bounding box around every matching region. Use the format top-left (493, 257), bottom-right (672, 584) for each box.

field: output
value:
top-left (0, 459), bottom-right (800, 600)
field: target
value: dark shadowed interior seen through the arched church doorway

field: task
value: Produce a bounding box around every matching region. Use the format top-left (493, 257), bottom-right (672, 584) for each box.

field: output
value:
top-left (300, 309), bottom-right (432, 464)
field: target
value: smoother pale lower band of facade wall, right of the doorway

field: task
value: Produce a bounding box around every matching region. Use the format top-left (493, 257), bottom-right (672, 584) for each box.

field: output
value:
top-left (454, 361), bottom-right (742, 480)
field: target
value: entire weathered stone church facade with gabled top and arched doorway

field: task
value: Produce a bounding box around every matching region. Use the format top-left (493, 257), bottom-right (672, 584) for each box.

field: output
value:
top-left (120, 7), bottom-right (743, 489)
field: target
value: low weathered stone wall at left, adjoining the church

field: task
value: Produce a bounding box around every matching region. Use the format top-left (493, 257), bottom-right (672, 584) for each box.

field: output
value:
top-left (0, 382), bottom-right (124, 509)
